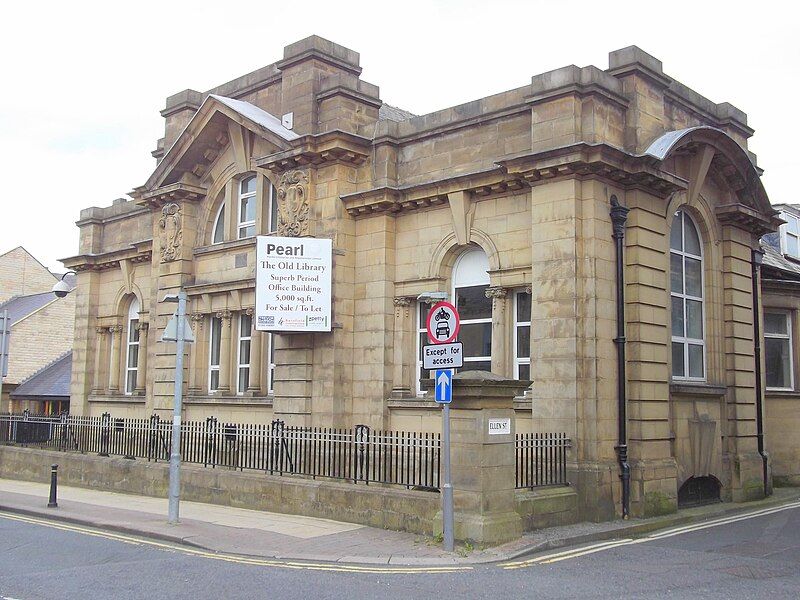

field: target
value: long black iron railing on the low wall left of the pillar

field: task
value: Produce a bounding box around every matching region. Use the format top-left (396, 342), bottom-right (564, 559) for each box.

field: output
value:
top-left (0, 413), bottom-right (441, 491)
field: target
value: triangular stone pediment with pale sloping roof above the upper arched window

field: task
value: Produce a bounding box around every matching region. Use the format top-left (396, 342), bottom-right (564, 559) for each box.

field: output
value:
top-left (143, 94), bottom-right (300, 190)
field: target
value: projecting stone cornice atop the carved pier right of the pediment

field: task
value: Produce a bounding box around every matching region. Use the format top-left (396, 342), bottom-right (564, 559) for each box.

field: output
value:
top-left (252, 130), bottom-right (372, 173)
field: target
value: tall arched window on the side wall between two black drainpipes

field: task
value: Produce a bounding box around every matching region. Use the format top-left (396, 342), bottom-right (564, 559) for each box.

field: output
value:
top-left (669, 210), bottom-right (706, 380)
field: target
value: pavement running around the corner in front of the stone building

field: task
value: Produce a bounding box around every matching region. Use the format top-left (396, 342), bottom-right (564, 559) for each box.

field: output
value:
top-left (0, 479), bottom-right (800, 566)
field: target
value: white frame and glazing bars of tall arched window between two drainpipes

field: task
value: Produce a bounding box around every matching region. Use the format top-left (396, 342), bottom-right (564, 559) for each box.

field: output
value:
top-left (667, 209), bottom-right (708, 382)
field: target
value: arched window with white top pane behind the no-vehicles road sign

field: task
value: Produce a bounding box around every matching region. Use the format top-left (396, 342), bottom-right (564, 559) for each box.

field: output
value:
top-left (452, 248), bottom-right (492, 371)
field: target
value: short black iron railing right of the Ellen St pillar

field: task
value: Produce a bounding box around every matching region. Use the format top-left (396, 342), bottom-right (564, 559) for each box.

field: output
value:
top-left (514, 433), bottom-right (572, 488)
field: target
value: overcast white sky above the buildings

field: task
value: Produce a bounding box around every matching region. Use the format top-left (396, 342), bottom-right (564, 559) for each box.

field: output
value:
top-left (0, 0), bottom-right (800, 270)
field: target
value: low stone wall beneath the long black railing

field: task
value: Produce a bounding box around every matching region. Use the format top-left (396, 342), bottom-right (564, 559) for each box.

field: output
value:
top-left (0, 446), bottom-right (440, 535)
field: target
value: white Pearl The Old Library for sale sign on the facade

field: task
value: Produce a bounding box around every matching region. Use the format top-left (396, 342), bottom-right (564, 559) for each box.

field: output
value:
top-left (255, 236), bottom-right (333, 331)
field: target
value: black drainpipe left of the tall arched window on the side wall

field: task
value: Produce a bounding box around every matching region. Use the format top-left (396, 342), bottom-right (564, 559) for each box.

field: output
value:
top-left (611, 195), bottom-right (631, 519)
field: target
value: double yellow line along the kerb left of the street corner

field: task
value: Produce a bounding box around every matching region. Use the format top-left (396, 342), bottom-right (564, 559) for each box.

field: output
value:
top-left (0, 512), bottom-right (473, 574)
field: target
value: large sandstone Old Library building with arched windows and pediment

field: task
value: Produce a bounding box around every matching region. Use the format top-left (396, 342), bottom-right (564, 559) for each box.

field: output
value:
top-left (64, 36), bottom-right (780, 519)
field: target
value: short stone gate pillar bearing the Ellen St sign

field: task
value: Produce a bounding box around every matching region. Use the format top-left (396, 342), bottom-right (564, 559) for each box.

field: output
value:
top-left (424, 371), bottom-right (531, 544)
